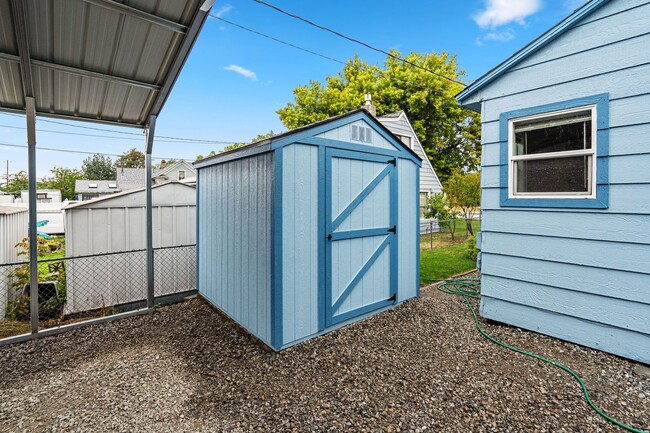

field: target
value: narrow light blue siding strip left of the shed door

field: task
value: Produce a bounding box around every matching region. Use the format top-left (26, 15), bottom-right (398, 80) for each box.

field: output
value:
top-left (281, 144), bottom-right (318, 344)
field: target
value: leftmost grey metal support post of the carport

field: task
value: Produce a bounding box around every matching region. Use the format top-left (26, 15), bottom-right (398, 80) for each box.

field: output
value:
top-left (25, 97), bottom-right (38, 334)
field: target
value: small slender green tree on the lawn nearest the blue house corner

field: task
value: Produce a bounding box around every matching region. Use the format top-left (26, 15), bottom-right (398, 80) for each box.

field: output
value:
top-left (443, 172), bottom-right (481, 235)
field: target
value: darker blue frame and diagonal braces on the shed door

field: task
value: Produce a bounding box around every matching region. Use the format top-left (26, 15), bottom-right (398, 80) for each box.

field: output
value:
top-left (321, 148), bottom-right (398, 327)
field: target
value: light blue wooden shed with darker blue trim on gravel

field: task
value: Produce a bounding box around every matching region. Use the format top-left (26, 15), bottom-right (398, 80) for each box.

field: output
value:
top-left (195, 109), bottom-right (421, 350)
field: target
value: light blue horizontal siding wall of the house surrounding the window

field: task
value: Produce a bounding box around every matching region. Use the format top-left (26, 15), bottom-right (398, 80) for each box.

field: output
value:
top-left (480, 0), bottom-right (650, 363)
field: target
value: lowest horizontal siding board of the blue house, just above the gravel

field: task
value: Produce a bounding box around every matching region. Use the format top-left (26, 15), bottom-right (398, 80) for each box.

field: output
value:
top-left (480, 296), bottom-right (650, 364)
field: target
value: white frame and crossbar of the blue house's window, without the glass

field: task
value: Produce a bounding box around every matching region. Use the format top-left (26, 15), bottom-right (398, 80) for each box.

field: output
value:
top-left (508, 105), bottom-right (598, 199)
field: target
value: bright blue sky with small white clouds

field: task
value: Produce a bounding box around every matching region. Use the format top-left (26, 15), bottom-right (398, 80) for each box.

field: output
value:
top-left (0, 0), bottom-right (584, 177)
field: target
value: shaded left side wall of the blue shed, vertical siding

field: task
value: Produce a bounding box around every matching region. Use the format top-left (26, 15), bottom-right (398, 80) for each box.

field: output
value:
top-left (197, 153), bottom-right (273, 345)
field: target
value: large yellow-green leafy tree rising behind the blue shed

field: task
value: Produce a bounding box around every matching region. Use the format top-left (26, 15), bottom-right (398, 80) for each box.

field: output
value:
top-left (277, 51), bottom-right (481, 183)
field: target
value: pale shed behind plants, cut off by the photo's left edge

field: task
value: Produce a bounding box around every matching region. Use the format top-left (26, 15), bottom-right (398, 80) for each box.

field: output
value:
top-left (0, 205), bottom-right (28, 320)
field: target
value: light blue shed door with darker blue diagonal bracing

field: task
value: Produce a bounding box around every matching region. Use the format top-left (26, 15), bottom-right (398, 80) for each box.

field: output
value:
top-left (325, 149), bottom-right (397, 326)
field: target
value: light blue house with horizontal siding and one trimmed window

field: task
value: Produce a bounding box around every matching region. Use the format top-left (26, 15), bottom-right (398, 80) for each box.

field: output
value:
top-left (458, 0), bottom-right (650, 364)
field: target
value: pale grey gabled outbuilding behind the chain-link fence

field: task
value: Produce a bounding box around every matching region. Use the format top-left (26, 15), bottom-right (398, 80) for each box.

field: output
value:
top-left (64, 182), bottom-right (196, 314)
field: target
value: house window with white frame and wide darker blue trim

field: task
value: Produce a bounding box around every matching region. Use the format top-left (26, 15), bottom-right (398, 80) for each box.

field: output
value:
top-left (496, 94), bottom-right (609, 209)
